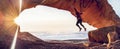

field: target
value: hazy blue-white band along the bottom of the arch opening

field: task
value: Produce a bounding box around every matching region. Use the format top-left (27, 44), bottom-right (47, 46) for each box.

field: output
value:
top-left (28, 31), bottom-right (88, 40)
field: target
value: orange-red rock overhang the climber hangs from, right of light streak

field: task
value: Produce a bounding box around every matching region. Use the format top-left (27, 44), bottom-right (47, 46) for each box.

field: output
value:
top-left (23, 0), bottom-right (120, 28)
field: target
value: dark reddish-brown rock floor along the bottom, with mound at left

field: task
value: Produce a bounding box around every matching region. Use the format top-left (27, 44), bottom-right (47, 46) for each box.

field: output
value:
top-left (0, 32), bottom-right (120, 49)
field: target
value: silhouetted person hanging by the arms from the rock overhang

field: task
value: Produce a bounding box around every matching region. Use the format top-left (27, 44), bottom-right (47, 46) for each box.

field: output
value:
top-left (74, 8), bottom-right (86, 31)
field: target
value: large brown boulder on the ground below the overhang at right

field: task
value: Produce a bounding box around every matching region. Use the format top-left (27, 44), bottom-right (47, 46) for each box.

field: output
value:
top-left (88, 26), bottom-right (120, 43)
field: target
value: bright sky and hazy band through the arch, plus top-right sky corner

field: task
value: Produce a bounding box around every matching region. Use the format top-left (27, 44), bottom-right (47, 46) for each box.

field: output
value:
top-left (15, 0), bottom-right (120, 40)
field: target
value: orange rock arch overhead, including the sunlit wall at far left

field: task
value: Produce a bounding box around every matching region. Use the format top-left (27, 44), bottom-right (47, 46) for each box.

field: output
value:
top-left (0, 0), bottom-right (120, 34)
